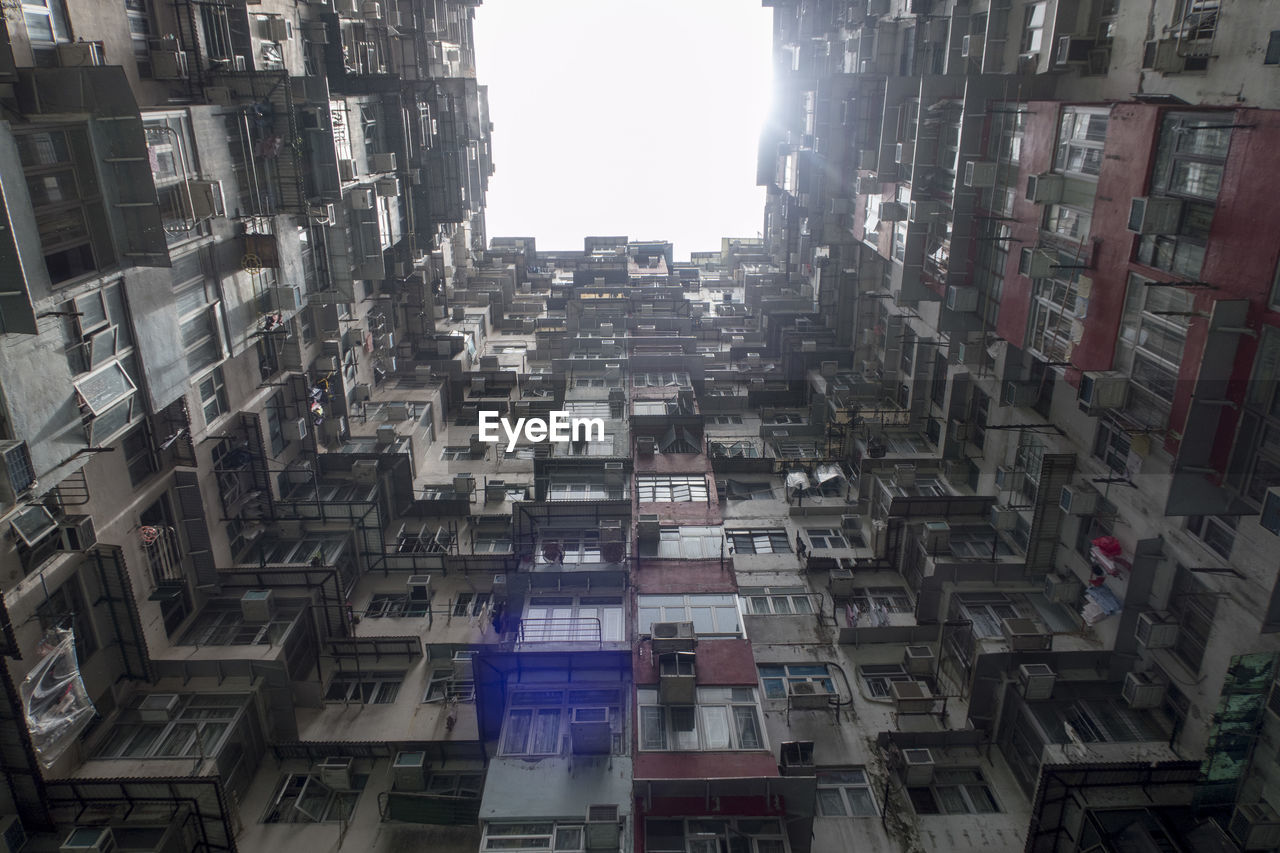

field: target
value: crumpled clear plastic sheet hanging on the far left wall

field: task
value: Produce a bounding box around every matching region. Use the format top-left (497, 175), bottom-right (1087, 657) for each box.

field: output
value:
top-left (20, 628), bottom-right (97, 768)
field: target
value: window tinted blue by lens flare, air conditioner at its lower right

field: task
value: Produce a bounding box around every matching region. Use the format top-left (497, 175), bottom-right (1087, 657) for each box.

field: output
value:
top-left (499, 686), bottom-right (622, 756)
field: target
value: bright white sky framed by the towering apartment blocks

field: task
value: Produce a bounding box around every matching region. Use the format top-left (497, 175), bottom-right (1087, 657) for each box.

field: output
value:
top-left (475, 0), bottom-right (773, 260)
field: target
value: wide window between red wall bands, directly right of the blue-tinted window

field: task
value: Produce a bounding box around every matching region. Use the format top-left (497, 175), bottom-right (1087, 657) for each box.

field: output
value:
top-left (636, 686), bottom-right (767, 751)
